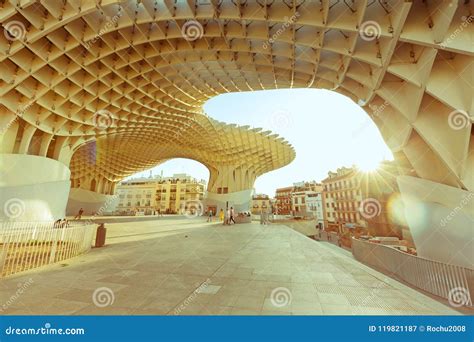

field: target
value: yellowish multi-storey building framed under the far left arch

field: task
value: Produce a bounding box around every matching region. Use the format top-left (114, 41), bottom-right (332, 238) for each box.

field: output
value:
top-left (117, 174), bottom-right (206, 214)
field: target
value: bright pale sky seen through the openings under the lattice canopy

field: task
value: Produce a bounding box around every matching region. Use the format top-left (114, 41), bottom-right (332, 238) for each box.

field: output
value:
top-left (129, 89), bottom-right (393, 196)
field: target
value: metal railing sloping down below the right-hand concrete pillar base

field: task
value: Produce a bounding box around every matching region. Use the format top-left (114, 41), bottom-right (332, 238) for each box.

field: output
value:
top-left (352, 238), bottom-right (474, 306)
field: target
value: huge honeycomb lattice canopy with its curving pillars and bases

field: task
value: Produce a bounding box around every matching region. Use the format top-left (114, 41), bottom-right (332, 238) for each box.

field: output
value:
top-left (0, 0), bottom-right (474, 264)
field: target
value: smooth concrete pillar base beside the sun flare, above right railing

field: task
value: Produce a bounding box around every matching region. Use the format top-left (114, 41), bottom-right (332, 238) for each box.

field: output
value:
top-left (397, 176), bottom-right (474, 269)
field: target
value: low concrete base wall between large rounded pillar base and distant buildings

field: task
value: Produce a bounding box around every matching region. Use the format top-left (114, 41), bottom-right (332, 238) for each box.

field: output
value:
top-left (66, 188), bottom-right (119, 216)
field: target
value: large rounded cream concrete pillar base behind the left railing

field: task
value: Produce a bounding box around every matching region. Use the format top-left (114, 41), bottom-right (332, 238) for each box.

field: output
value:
top-left (0, 154), bottom-right (71, 221)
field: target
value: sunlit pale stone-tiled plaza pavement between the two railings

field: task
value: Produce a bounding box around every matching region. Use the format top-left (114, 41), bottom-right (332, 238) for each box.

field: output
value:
top-left (0, 217), bottom-right (459, 315)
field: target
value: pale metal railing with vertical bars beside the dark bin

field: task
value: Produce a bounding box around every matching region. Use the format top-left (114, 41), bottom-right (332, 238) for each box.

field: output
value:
top-left (0, 222), bottom-right (96, 277)
